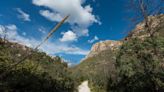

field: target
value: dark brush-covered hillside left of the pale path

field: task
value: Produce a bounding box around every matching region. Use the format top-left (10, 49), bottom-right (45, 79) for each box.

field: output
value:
top-left (0, 39), bottom-right (74, 92)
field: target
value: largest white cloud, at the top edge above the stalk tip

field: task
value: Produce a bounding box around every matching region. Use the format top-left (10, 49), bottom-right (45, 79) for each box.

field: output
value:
top-left (33, 0), bottom-right (101, 37)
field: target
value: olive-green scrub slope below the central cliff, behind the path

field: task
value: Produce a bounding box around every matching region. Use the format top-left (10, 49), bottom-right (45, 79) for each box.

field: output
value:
top-left (71, 49), bottom-right (115, 92)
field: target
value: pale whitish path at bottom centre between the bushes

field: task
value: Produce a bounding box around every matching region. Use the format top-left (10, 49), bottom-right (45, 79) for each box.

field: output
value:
top-left (78, 81), bottom-right (91, 92)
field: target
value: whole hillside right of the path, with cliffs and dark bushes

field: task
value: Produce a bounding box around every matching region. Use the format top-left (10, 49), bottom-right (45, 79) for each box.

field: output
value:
top-left (72, 14), bottom-right (164, 92)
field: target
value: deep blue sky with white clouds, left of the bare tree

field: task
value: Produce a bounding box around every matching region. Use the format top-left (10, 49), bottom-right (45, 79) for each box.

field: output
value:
top-left (0, 0), bottom-right (136, 64)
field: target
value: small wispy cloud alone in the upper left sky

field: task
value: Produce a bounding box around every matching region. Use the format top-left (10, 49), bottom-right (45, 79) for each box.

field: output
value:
top-left (16, 8), bottom-right (31, 21)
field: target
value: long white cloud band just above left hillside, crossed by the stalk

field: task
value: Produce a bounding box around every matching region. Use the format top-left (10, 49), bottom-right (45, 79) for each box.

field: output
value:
top-left (0, 24), bottom-right (89, 55)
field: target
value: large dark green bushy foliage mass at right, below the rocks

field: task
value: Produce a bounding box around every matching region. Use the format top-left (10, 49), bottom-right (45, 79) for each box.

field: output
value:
top-left (108, 29), bottom-right (164, 92)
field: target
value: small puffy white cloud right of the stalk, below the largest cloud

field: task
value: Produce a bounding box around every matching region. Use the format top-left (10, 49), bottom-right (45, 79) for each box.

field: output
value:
top-left (59, 30), bottom-right (77, 42)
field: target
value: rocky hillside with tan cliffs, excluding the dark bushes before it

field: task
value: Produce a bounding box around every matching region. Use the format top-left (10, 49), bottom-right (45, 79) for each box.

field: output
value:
top-left (73, 15), bottom-right (164, 92)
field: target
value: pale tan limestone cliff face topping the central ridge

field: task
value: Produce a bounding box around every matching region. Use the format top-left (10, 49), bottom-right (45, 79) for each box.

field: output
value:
top-left (87, 40), bottom-right (122, 57)
